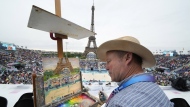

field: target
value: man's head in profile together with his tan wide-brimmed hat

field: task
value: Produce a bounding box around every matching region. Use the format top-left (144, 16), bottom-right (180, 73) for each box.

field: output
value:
top-left (97, 36), bottom-right (155, 82)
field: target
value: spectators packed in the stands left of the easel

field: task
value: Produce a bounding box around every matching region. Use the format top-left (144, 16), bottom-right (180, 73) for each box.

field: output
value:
top-left (0, 48), bottom-right (43, 84)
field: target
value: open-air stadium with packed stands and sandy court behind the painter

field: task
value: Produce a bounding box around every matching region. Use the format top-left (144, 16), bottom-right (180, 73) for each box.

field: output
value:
top-left (0, 41), bottom-right (190, 105)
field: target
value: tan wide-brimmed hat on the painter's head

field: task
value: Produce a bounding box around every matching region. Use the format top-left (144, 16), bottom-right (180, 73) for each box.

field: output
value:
top-left (97, 36), bottom-right (156, 68)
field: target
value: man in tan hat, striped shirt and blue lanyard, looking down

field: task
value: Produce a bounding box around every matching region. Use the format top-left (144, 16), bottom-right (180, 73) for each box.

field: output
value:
top-left (97, 36), bottom-right (173, 107)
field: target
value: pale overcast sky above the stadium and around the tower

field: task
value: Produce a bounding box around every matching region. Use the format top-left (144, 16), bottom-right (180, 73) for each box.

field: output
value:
top-left (0, 0), bottom-right (190, 53)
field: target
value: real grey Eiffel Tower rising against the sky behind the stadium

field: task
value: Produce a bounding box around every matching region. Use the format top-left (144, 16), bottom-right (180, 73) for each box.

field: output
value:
top-left (83, 3), bottom-right (97, 57)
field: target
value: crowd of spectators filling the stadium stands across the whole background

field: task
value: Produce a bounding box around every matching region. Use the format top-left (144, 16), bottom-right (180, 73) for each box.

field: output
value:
top-left (0, 48), bottom-right (190, 86)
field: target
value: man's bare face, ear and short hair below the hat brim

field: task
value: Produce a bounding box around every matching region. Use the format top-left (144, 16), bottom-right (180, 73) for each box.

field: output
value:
top-left (106, 50), bottom-right (142, 82)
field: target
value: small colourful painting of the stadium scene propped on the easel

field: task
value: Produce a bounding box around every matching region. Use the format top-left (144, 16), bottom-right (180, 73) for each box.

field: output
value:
top-left (42, 58), bottom-right (82, 105)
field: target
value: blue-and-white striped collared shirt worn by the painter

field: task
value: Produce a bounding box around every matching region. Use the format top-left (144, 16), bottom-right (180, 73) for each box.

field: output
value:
top-left (107, 73), bottom-right (174, 107)
